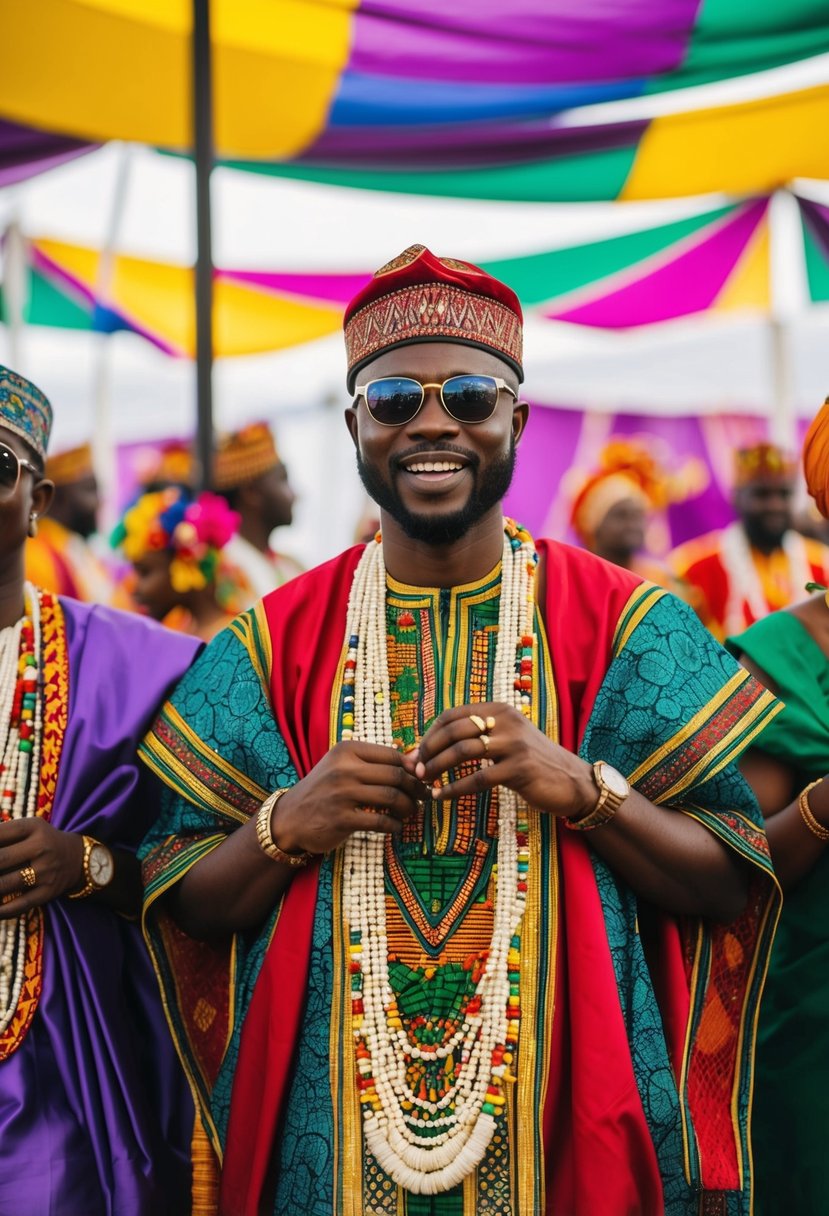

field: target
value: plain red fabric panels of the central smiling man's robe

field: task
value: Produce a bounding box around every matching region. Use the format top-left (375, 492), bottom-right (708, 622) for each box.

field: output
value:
top-left (220, 540), bottom-right (675, 1216)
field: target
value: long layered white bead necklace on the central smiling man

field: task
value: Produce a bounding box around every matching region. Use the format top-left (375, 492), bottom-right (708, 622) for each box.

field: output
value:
top-left (340, 520), bottom-right (537, 1194)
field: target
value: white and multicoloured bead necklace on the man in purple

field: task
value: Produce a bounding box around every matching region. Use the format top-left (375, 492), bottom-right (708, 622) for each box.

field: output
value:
top-left (0, 582), bottom-right (43, 1034)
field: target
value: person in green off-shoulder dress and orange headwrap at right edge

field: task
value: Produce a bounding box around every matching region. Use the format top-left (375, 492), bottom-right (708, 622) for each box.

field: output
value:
top-left (728, 404), bottom-right (829, 1216)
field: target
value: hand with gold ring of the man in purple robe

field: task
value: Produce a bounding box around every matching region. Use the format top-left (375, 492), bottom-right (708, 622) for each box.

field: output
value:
top-left (0, 818), bottom-right (84, 919)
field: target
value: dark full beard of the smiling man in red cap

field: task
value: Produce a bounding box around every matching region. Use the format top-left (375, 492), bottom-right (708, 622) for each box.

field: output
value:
top-left (357, 435), bottom-right (515, 545)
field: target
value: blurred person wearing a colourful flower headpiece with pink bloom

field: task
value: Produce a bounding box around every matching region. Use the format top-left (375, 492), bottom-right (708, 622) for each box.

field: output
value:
top-left (112, 486), bottom-right (239, 641)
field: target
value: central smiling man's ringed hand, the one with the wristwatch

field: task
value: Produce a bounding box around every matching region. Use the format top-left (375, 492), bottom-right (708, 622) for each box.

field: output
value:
top-left (405, 702), bottom-right (598, 816)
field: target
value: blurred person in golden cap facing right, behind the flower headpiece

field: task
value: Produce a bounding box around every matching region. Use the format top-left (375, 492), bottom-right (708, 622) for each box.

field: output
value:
top-left (214, 422), bottom-right (301, 608)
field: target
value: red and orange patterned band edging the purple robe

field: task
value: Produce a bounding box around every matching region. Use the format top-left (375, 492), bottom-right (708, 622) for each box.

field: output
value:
top-left (0, 592), bottom-right (69, 1062)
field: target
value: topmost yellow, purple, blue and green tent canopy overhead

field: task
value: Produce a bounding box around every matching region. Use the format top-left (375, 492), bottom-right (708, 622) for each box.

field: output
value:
top-left (0, 0), bottom-right (829, 201)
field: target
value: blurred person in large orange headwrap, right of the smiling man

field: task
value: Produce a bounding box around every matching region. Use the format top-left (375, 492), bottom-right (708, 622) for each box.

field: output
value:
top-left (570, 437), bottom-right (704, 598)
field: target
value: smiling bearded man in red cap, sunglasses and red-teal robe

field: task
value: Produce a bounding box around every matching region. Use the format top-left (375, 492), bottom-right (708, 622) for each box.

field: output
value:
top-left (142, 246), bottom-right (777, 1216)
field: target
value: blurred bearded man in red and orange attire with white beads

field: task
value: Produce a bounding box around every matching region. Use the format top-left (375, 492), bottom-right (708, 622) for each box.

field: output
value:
top-left (669, 444), bottom-right (829, 641)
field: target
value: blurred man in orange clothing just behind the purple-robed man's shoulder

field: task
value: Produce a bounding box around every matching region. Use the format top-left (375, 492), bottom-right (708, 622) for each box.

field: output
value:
top-left (26, 444), bottom-right (115, 603)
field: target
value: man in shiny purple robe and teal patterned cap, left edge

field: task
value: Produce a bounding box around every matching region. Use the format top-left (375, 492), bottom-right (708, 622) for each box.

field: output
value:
top-left (0, 367), bottom-right (197, 1216)
